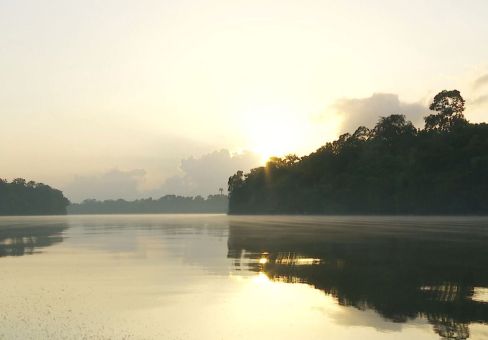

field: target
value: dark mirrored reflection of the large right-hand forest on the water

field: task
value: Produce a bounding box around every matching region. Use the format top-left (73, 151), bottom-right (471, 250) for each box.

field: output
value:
top-left (228, 222), bottom-right (488, 339)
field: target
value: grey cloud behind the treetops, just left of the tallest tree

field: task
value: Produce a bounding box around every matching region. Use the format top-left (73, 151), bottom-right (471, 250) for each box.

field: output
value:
top-left (333, 93), bottom-right (428, 133)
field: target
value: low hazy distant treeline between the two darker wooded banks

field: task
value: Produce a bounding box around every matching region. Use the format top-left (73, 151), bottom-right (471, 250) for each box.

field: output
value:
top-left (68, 195), bottom-right (228, 214)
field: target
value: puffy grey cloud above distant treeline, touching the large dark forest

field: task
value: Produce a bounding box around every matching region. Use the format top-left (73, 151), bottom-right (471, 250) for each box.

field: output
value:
top-left (154, 149), bottom-right (260, 196)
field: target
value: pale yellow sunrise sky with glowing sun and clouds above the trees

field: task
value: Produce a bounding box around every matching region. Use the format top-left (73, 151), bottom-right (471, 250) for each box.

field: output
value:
top-left (0, 0), bottom-right (488, 201)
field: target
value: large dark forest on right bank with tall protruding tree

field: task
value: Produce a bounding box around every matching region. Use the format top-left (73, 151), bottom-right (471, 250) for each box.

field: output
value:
top-left (228, 90), bottom-right (488, 214)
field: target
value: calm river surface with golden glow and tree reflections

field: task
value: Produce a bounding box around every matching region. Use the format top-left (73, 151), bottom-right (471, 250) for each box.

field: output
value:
top-left (0, 215), bottom-right (488, 339)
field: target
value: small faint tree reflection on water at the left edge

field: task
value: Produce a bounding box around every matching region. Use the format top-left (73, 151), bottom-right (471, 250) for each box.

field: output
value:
top-left (0, 224), bottom-right (67, 257)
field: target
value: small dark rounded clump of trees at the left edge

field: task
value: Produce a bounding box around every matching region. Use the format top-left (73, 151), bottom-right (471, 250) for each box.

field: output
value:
top-left (0, 178), bottom-right (69, 215)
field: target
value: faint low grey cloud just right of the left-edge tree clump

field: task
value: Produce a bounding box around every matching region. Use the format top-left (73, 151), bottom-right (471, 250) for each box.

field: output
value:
top-left (63, 169), bottom-right (146, 202)
